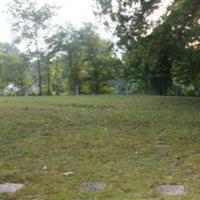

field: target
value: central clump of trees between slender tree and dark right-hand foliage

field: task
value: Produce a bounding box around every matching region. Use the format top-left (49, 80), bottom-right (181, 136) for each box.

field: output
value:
top-left (47, 24), bottom-right (122, 94)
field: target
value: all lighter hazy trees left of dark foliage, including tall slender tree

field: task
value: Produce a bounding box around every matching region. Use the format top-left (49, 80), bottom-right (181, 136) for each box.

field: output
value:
top-left (0, 0), bottom-right (122, 95)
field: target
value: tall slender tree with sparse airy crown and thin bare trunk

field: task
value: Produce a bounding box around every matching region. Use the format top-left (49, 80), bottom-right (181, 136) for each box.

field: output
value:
top-left (8, 0), bottom-right (55, 95)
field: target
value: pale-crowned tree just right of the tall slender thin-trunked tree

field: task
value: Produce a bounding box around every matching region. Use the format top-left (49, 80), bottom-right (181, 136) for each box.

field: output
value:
top-left (47, 24), bottom-right (84, 94)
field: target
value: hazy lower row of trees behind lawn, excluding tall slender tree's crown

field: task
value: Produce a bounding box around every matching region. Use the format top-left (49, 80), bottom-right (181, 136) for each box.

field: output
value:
top-left (0, 24), bottom-right (122, 95)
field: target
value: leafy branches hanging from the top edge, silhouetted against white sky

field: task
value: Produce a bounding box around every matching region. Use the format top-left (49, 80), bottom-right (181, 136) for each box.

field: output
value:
top-left (96, 0), bottom-right (160, 48)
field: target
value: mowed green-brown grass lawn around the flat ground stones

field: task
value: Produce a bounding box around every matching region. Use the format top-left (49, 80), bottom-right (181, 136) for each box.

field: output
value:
top-left (0, 95), bottom-right (200, 200)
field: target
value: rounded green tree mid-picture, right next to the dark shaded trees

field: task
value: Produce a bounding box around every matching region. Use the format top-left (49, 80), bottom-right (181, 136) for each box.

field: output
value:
top-left (79, 23), bottom-right (122, 94)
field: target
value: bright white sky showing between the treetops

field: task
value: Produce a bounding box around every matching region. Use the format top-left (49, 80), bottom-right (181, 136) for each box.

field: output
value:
top-left (0, 0), bottom-right (172, 42)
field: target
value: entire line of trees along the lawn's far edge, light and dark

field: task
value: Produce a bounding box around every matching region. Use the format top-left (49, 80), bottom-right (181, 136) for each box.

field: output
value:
top-left (0, 0), bottom-right (200, 96)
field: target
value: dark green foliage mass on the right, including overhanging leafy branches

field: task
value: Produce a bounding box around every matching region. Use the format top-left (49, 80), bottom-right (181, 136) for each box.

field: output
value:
top-left (97, 0), bottom-right (200, 95)
